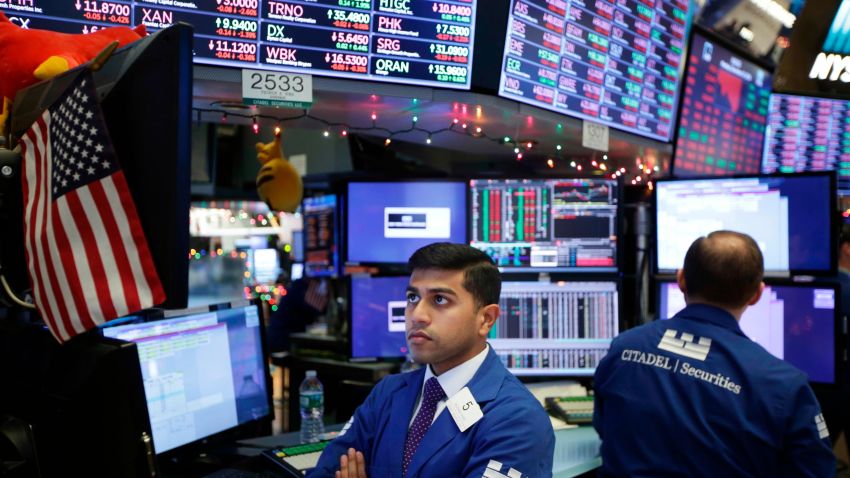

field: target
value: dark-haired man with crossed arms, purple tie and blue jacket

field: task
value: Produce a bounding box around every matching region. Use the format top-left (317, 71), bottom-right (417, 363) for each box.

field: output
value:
top-left (308, 243), bottom-right (555, 478)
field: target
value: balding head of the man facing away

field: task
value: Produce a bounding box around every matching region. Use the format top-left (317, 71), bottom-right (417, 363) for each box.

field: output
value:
top-left (683, 231), bottom-right (764, 309)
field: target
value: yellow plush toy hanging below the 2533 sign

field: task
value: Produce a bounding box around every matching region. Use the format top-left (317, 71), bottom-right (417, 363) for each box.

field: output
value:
top-left (256, 129), bottom-right (304, 212)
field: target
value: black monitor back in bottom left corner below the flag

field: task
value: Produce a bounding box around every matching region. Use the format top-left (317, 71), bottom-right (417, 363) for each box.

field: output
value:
top-left (0, 322), bottom-right (159, 478)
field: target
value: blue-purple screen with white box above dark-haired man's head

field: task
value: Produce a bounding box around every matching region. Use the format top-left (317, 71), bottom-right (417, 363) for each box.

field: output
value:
top-left (346, 181), bottom-right (466, 264)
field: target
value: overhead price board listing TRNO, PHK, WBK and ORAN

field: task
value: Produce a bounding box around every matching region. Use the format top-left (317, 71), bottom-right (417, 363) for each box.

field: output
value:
top-left (0, 0), bottom-right (476, 89)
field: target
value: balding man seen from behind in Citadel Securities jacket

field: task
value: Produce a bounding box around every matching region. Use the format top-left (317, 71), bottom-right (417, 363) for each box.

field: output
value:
top-left (593, 231), bottom-right (835, 478)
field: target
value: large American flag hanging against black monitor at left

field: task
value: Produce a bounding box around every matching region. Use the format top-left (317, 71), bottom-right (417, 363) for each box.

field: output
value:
top-left (21, 71), bottom-right (165, 342)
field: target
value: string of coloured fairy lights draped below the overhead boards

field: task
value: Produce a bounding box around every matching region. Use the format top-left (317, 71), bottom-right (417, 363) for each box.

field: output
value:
top-left (192, 108), bottom-right (660, 188)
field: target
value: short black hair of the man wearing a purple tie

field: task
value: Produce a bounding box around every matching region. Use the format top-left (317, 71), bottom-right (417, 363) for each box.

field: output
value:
top-left (407, 242), bottom-right (502, 308)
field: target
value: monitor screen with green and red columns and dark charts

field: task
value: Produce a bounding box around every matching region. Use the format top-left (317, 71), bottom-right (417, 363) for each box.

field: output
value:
top-left (469, 179), bottom-right (620, 272)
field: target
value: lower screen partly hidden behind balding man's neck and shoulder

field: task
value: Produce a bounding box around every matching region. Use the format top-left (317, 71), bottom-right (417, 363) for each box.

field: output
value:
top-left (657, 281), bottom-right (844, 383)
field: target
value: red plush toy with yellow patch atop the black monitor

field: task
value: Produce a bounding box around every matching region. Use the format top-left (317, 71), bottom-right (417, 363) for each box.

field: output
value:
top-left (0, 12), bottom-right (147, 133)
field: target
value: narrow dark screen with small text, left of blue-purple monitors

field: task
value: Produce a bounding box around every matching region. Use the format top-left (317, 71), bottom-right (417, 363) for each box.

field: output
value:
top-left (301, 194), bottom-right (339, 277)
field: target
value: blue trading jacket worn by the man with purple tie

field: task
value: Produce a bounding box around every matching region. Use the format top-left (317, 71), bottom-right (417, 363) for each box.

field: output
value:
top-left (307, 348), bottom-right (555, 478)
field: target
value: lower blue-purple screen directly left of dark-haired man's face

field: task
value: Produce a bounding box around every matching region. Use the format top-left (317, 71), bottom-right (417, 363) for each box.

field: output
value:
top-left (351, 275), bottom-right (409, 358)
